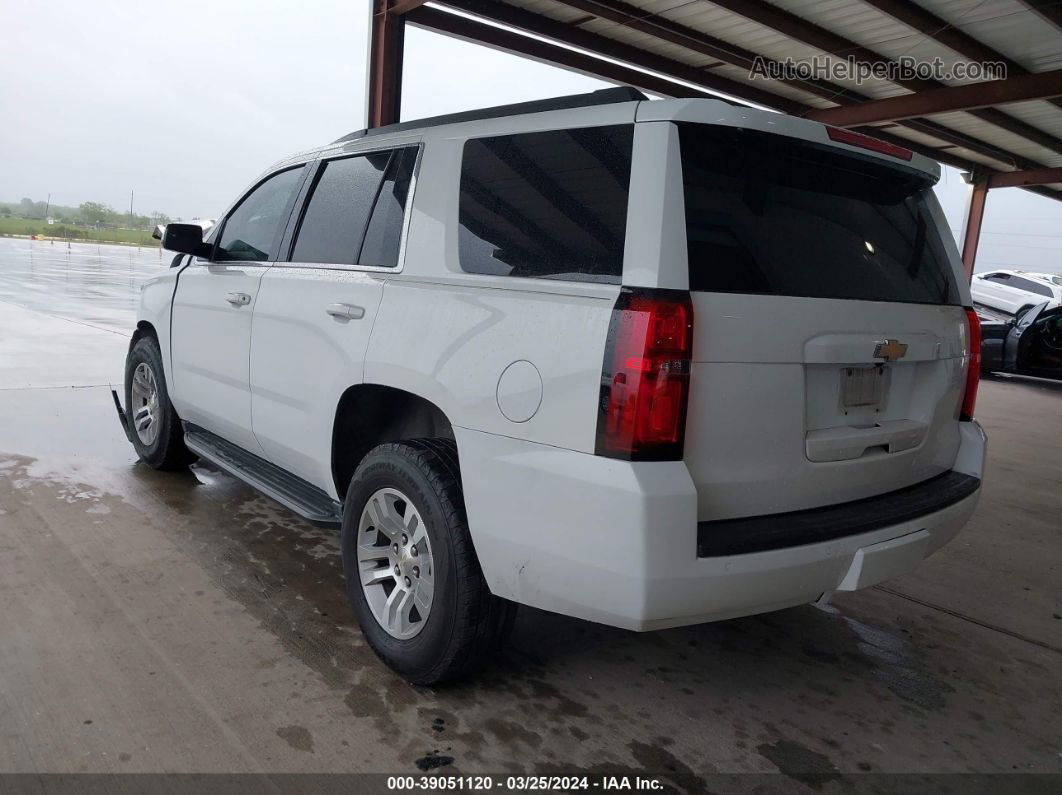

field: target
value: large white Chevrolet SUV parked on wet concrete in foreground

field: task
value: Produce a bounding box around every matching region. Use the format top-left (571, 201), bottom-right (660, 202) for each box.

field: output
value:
top-left (116, 89), bottom-right (986, 682)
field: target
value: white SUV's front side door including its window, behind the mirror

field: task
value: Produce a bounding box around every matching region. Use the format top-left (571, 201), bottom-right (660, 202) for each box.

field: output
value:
top-left (170, 166), bottom-right (304, 452)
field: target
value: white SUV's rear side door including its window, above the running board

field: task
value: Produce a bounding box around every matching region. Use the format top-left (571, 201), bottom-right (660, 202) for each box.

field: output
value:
top-left (251, 146), bottom-right (418, 491)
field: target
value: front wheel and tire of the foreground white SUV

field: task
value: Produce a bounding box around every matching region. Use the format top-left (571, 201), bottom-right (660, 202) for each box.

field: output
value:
top-left (125, 336), bottom-right (195, 469)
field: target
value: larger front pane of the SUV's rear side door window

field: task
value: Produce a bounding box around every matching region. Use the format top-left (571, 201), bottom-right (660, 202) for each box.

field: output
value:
top-left (291, 152), bottom-right (391, 265)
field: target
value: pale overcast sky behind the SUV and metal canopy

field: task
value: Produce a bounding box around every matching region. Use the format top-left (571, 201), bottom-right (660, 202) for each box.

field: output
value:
top-left (0, 0), bottom-right (1062, 273)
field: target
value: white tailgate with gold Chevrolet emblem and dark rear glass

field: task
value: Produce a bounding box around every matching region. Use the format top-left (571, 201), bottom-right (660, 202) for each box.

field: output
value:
top-left (679, 123), bottom-right (965, 520)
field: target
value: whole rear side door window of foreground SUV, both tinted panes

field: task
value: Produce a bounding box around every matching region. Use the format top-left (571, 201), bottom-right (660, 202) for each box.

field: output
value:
top-left (291, 146), bottom-right (417, 267)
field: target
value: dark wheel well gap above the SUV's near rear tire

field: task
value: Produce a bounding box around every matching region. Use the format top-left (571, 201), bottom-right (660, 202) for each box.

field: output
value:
top-left (331, 383), bottom-right (460, 499)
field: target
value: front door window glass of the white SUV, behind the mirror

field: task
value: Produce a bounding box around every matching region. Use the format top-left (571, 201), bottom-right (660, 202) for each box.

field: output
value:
top-left (213, 167), bottom-right (304, 262)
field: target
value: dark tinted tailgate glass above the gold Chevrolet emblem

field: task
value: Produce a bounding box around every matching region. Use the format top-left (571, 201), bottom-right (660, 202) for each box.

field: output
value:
top-left (679, 124), bottom-right (959, 304)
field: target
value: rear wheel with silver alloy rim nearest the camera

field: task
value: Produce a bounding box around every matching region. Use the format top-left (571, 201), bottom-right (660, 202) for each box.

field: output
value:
top-left (342, 439), bottom-right (516, 685)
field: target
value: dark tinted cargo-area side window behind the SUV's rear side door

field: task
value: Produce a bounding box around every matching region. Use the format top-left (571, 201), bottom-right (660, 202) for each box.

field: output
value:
top-left (458, 124), bottom-right (634, 284)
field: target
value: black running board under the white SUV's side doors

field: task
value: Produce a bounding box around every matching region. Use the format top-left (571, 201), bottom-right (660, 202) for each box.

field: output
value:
top-left (185, 422), bottom-right (343, 528)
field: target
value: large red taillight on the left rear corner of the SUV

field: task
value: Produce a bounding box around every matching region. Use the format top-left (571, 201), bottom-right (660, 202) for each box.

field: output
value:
top-left (597, 288), bottom-right (693, 461)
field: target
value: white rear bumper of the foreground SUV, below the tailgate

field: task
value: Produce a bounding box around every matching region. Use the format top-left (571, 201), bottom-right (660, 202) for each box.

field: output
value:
top-left (455, 422), bottom-right (986, 630)
